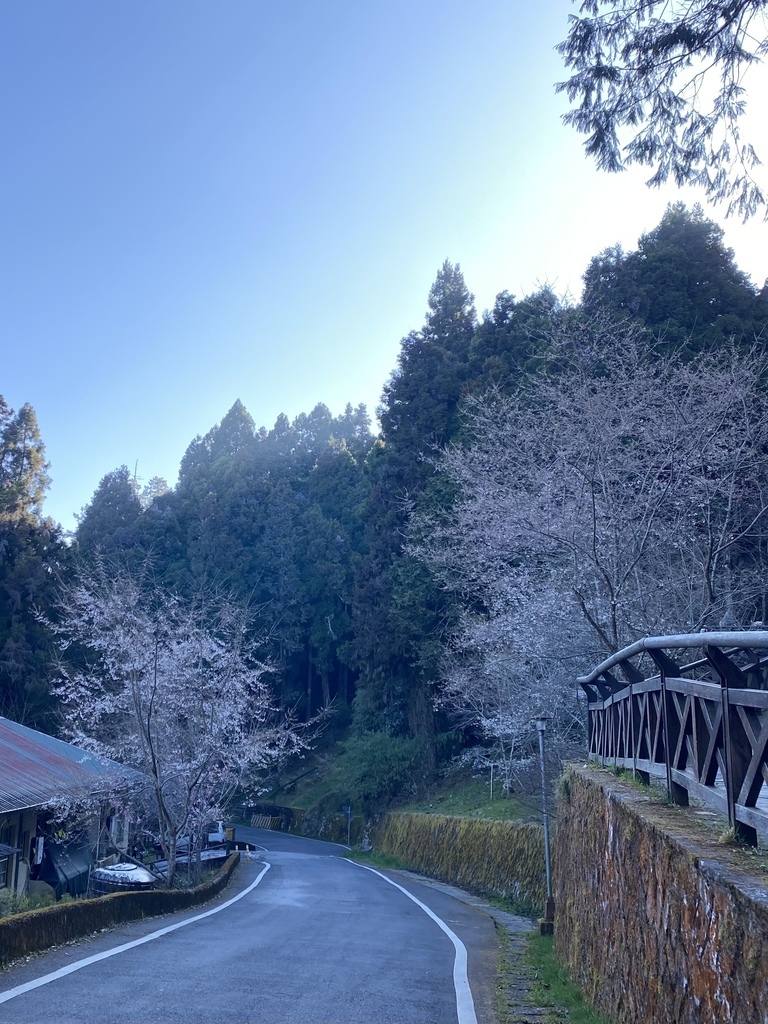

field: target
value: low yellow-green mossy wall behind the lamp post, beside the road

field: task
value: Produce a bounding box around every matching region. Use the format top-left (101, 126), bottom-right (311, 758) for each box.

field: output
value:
top-left (373, 812), bottom-right (547, 913)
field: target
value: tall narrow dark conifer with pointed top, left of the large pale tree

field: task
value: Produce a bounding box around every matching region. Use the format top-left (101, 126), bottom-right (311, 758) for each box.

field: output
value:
top-left (355, 260), bottom-right (476, 770)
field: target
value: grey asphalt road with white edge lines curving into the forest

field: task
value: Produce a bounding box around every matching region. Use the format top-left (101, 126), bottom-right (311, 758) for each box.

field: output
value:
top-left (0, 827), bottom-right (497, 1024)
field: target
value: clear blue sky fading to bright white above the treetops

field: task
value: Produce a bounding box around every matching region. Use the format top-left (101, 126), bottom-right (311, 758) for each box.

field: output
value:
top-left (0, 0), bottom-right (768, 527)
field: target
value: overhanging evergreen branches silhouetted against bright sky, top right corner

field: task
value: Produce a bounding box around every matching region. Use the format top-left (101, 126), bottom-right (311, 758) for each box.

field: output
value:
top-left (557, 0), bottom-right (768, 218)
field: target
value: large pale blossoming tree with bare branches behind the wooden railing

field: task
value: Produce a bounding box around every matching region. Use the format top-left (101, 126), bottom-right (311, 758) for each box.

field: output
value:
top-left (412, 317), bottom-right (768, 774)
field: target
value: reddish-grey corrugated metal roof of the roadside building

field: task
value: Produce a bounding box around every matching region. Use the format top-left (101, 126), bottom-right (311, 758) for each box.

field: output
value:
top-left (0, 718), bottom-right (138, 812)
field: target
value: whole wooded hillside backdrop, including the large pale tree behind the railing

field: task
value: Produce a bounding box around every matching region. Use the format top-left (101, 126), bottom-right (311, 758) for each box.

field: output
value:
top-left (0, 205), bottom-right (768, 801)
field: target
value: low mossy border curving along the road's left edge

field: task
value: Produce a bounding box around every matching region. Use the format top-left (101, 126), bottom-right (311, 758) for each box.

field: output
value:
top-left (0, 853), bottom-right (240, 963)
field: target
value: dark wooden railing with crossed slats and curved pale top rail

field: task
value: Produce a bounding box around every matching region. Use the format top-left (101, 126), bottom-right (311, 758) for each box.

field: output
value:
top-left (579, 631), bottom-right (768, 843)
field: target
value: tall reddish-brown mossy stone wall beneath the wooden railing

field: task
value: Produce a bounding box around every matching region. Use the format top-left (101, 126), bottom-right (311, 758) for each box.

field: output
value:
top-left (553, 768), bottom-right (768, 1024)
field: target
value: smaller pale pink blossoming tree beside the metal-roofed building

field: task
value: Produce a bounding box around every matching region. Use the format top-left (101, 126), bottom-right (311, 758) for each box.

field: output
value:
top-left (46, 561), bottom-right (304, 886)
